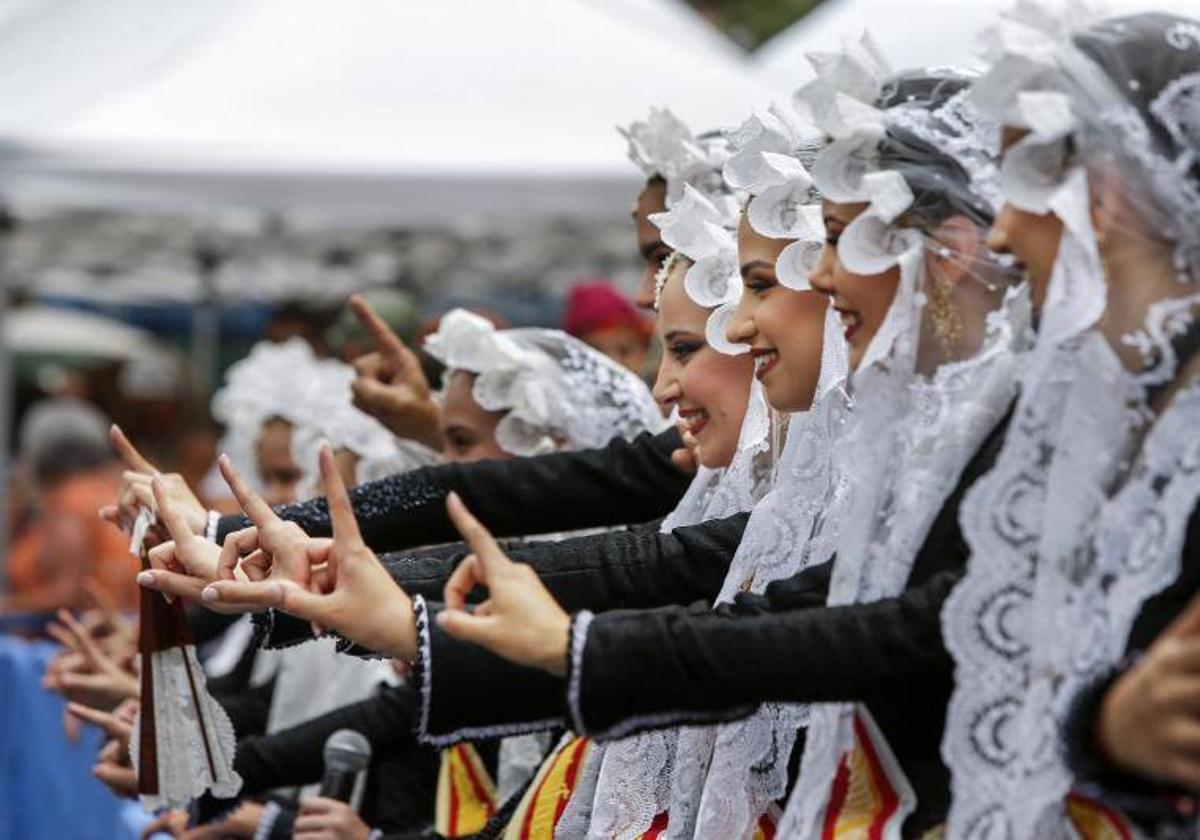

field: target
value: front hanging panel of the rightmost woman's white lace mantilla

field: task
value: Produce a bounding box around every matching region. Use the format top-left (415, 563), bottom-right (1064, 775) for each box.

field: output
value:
top-left (942, 193), bottom-right (1144, 839)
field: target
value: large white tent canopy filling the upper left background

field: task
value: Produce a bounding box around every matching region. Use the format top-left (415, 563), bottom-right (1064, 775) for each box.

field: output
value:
top-left (0, 0), bottom-right (772, 223)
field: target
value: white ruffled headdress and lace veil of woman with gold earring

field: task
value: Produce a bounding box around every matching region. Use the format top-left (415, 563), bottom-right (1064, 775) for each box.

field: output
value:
top-left (780, 36), bottom-right (1027, 836)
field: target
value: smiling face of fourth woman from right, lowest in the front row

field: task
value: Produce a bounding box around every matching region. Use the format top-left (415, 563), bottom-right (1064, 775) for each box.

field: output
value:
top-left (654, 260), bottom-right (750, 469)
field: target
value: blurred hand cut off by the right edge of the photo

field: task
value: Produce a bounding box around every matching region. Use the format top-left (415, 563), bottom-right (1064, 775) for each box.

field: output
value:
top-left (1096, 588), bottom-right (1200, 791)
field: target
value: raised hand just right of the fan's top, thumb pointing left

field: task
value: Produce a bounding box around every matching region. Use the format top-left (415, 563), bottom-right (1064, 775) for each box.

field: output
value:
top-left (138, 478), bottom-right (245, 612)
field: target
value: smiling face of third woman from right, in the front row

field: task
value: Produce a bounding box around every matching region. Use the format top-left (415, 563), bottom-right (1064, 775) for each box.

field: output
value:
top-left (726, 214), bottom-right (829, 412)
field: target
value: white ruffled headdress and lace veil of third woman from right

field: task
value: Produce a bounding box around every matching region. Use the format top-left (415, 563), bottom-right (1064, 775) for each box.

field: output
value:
top-left (667, 107), bottom-right (846, 838)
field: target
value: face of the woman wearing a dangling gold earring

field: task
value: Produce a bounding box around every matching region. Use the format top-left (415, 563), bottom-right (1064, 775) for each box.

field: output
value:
top-left (809, 200), bottom-right (900, 370)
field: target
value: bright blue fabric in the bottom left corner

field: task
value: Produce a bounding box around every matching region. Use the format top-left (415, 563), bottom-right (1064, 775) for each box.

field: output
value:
top-left (0, 636), bottom-right (137, 840)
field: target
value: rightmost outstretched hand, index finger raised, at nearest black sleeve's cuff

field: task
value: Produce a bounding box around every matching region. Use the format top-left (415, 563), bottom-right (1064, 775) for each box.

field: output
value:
top-left (438, 493), bottom-right (571, 676)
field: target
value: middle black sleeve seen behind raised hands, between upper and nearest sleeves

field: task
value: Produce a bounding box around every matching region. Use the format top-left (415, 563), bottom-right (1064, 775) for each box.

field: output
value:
top-left (256, 514), bottom-right (749, 653)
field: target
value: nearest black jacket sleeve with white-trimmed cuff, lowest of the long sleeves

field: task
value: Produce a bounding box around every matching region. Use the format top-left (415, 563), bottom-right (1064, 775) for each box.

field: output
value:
top-left (568, 570), bottom-right (961, 737)
